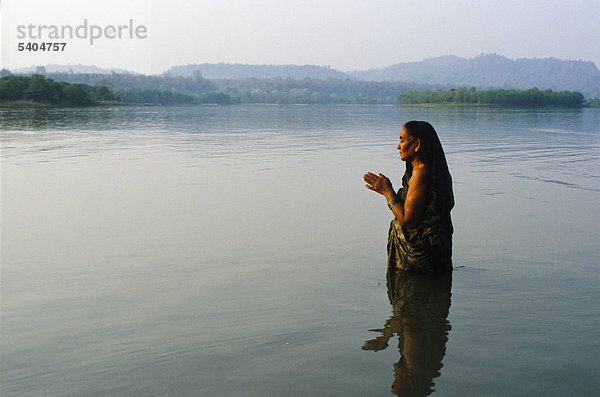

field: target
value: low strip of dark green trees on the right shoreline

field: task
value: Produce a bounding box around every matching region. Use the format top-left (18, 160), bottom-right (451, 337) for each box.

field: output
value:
top-left (398, 87), bottom-right (584, 107)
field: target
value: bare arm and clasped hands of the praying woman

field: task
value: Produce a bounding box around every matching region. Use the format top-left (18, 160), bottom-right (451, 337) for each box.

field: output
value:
top-left (363, 167), bottom-right (427, 227)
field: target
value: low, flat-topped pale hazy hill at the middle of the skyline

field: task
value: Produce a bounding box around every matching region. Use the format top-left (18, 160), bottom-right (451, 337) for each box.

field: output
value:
top-left (164, 63), bottom-right (350, 80)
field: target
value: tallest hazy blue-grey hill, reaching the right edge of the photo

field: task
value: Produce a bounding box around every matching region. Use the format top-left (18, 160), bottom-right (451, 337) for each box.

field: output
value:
top-left (348, 54), bottom-right (600, 98)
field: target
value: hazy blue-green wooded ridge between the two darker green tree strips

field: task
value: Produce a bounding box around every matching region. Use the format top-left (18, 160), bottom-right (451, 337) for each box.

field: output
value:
top-left (39, 70), bottom-right (440, 104)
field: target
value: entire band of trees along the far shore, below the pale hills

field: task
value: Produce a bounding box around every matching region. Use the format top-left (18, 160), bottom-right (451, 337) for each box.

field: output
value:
top-left (0, 70), bottom-right (600, 107)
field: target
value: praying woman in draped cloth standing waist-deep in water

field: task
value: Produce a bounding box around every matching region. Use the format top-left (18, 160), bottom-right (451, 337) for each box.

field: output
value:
top-left (363, 121), bottom-right (454, 273)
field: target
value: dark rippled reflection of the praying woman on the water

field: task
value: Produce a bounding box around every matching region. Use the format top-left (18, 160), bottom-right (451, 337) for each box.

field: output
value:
top-left (362, 269), bottom-right (452, 396)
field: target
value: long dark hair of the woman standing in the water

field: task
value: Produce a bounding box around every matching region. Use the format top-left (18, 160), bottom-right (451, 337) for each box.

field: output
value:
top-left (402, 121), bottom-right (454, 213)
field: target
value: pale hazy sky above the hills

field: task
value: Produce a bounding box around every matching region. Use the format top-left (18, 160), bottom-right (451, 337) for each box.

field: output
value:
top-left (0, 0), bottom-right (600, 73)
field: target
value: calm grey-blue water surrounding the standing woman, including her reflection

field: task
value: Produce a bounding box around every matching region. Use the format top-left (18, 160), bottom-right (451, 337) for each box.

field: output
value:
top-left (0, 106), bottom-right (600, 396)
